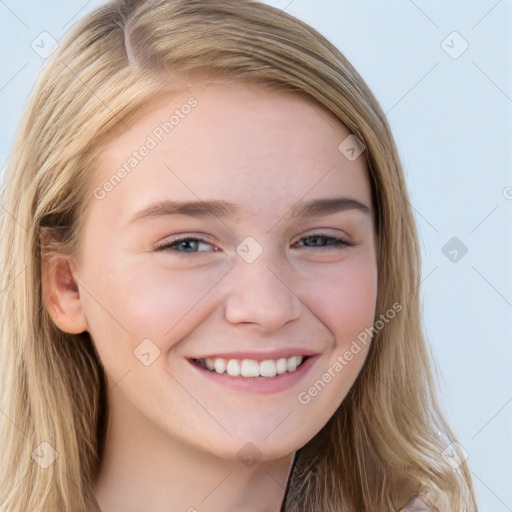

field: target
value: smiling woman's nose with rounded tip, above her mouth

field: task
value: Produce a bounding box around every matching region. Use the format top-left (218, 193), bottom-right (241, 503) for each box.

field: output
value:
top-left (224, 252), bottom-right (302, 332)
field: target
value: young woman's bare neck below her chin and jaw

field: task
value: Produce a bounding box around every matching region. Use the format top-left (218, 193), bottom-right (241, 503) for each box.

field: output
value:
top-left (94, 386), bottom-right (294, 512)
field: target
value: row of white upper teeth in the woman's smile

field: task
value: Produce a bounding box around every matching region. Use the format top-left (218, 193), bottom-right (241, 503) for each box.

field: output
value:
top-left (198, 356), bottom-right (303, 377)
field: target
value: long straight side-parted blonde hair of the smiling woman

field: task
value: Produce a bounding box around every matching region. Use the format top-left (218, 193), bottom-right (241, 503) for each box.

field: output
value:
top-left (0, 0), bottom-right (476, 512)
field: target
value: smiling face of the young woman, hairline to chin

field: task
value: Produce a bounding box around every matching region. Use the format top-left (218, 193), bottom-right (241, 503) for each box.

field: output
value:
top-left (76, 83), bottom-right (377, 460)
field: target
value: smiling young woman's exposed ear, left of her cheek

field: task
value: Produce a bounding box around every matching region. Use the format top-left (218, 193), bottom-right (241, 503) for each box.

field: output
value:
top-left (41, 255), bottom-right (88, 334)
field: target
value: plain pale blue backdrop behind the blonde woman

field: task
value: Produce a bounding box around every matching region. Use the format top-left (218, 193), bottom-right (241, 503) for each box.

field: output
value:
top-left (0, 0), bottom-right (512, 512)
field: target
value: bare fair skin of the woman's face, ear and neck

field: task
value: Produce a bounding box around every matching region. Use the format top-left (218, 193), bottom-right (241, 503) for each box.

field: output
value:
top-left (44, 81), bottom-right (377, 512)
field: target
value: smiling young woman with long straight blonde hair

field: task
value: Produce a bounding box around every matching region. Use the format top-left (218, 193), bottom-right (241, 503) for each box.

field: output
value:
top-left (0, 0), bottom-right (476, 512)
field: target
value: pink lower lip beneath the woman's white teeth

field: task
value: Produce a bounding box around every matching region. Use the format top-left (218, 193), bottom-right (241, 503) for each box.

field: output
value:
top-left (189, 355), bottom-right (318, 394)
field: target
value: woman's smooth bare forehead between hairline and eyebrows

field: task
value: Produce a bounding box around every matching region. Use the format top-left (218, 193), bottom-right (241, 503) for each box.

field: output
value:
top-left (90, 82), bottom-right (370, 221)
